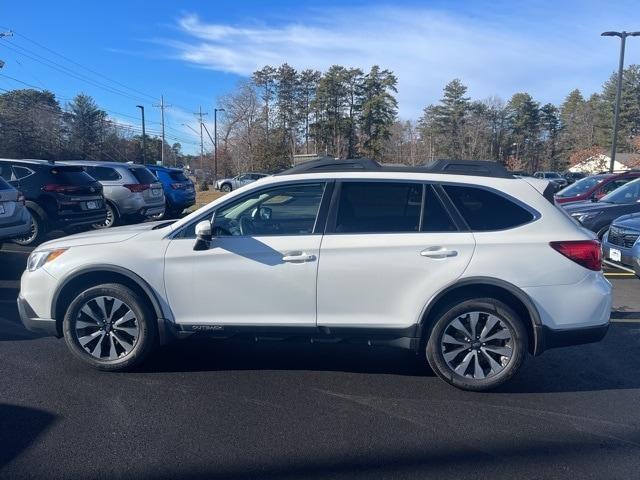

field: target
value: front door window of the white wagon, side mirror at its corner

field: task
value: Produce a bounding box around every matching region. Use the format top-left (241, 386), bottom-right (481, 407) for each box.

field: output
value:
top-left (214, 182), bottom-right (325, 237)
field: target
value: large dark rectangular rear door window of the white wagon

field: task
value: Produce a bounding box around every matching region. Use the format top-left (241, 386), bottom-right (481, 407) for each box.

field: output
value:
top-left (336, 182), bottom-right (422, 233)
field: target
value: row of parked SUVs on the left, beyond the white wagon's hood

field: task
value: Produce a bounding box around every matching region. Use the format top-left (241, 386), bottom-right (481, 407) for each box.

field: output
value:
top-left (0, 159), bottom-right (195, 245)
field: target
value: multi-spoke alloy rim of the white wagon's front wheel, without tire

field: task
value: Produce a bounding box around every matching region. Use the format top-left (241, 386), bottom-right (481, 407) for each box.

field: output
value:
top-left (73, 296), bottom-right (140, 360)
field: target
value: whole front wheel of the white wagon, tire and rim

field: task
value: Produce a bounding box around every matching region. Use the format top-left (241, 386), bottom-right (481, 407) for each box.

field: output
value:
top-left (62, 283), bottom-right (157, 371)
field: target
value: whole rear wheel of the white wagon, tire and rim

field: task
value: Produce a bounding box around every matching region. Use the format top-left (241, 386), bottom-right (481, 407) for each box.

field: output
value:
top-left (427, 298), bottom-right (527, 391)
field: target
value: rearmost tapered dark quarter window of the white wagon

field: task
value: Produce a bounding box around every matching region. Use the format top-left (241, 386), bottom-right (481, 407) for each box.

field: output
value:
top-left (443, 185), bottom-right (534, 232)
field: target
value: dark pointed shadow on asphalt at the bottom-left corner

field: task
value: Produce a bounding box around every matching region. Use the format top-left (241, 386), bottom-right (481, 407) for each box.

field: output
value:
top-left (0, 403), bottom-right (56, 468)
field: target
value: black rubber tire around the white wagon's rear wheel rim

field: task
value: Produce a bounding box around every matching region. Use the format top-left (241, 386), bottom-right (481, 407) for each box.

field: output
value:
top-left (426, 298), bottom-right (528, 391)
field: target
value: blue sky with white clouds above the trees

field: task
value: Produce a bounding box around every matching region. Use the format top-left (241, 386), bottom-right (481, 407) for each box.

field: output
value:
top-left (0, 0), bottom-right (640, 153)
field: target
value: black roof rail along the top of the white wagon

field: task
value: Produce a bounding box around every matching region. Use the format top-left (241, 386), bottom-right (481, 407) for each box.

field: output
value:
top-left (276, 158), bottom-right (514, 178)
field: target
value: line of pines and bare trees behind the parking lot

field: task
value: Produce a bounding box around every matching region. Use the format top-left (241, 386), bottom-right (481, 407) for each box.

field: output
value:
top-left (0, 63), bottom-right (640, 175)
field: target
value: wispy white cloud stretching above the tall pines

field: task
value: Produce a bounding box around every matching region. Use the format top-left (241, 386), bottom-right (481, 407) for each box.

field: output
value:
top-left (164, 6), bottom-right (632, 118)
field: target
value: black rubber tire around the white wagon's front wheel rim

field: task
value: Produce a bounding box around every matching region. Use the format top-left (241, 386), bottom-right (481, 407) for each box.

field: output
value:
top-left (62, 283), bottom-right (158, 372)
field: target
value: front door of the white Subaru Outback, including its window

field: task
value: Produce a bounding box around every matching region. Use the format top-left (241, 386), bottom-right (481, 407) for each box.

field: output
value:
top-left (165, 182), bottom-right (330, 326)
